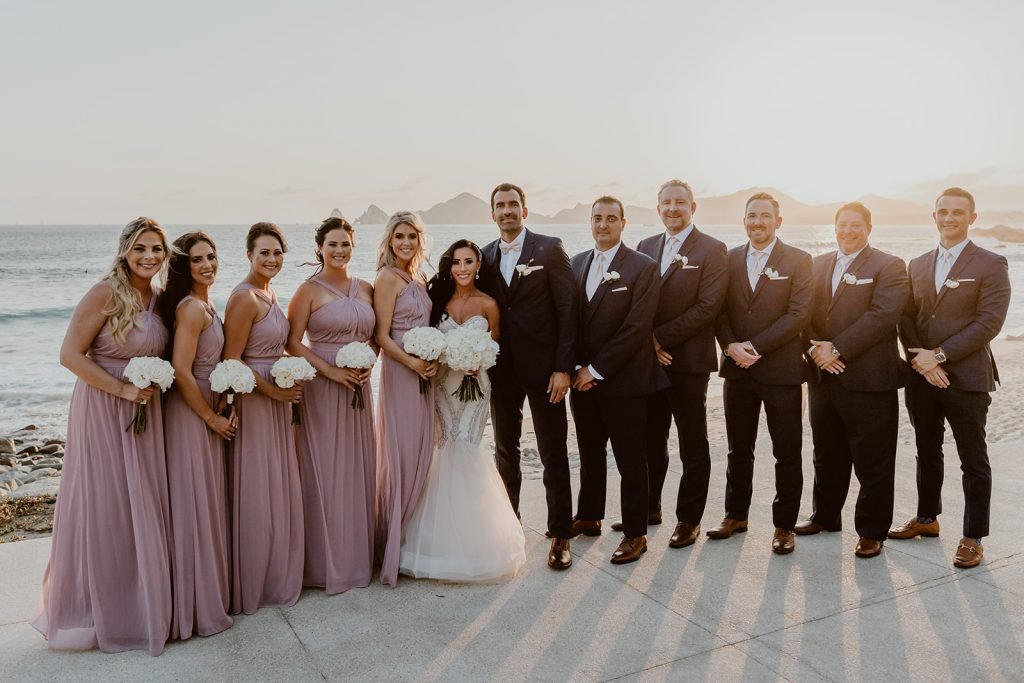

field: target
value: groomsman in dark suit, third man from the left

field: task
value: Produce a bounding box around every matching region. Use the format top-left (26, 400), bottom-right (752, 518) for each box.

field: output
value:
top-left (611, 180), bottom-right (729, 548)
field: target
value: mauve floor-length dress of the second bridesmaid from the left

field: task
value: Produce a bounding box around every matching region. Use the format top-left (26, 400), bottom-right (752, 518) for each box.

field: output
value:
top-left (164, 296), bottom-right (231, 640)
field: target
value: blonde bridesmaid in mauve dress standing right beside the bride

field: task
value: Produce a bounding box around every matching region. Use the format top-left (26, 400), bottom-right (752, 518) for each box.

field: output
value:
top-left (374, 211), bottom-right (437, 587)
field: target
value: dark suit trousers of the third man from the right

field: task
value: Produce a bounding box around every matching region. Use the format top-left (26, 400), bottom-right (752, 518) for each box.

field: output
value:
top-left (723, 379), bottom-right (804, 530)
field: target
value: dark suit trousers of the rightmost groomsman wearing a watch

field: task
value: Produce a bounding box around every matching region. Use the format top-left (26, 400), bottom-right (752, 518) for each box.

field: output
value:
top-left (906, 378), bottom-right (992, 539)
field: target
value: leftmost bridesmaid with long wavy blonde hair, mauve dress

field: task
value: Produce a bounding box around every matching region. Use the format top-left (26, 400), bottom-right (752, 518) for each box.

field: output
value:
top-left (32, 218), bottom-right (171, 655)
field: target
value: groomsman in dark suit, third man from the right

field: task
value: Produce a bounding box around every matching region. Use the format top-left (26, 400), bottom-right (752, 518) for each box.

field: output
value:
top-left (708, 193), bottom-right (812, 554)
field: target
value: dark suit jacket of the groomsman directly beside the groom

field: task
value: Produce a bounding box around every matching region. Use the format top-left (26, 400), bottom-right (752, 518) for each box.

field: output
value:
top-left (571, 244), bottom-right (669, 396)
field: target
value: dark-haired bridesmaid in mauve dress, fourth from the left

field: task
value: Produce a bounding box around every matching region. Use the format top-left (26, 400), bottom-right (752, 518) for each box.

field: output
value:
top-left (288, 218), bottom-right (377, 594)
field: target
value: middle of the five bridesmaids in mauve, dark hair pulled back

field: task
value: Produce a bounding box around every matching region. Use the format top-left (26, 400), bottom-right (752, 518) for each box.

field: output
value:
top-left (224, 223), bottom-right (303, 614)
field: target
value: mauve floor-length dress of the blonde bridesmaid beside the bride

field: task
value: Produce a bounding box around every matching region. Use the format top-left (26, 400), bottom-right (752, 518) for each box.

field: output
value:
top-left (377, 273), bottom-right (434, 587)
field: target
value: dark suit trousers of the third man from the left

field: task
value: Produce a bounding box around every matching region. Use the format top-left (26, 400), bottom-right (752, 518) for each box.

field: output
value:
top-left (647, 373), bottom-right (711, 525)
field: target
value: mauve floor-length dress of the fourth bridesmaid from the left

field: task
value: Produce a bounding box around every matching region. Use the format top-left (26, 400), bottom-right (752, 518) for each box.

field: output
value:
top-left (295, 278), bottom-right (377, 594)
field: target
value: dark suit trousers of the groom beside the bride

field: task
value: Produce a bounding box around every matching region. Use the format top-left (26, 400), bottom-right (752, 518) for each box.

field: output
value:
top-left (490, 382), bottom-right (572, 539)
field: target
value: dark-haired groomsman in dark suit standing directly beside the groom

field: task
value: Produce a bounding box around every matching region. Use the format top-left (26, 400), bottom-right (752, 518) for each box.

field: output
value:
top-left (569, 197), bottom-right (669, 564)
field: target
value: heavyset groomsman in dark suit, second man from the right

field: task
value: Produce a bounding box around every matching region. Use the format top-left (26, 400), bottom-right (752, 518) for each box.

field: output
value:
top-left (796, 202), bottom-right (909, 557)
